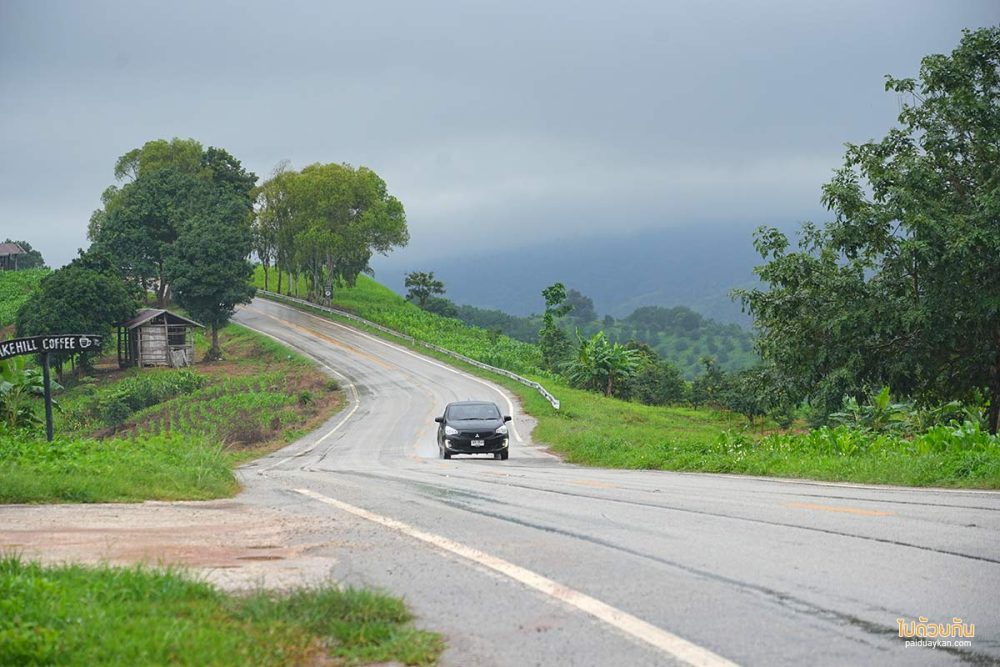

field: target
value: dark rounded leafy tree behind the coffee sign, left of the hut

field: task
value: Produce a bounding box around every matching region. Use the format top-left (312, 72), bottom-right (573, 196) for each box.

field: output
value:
top-left (17, 253), bottom-right (138, 368)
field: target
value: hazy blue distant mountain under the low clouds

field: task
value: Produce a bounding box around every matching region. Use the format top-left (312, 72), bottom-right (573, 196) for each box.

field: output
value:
top-left (374, 225), bottom-right (760, 326)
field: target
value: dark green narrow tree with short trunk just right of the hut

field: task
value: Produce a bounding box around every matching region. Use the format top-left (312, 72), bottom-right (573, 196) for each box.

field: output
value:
top-left (166, 188), bottom-right (256, 360)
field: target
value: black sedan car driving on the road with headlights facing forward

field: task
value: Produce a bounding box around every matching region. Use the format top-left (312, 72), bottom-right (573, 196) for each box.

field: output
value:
top-left (434, 401), bottom-right (510, 461)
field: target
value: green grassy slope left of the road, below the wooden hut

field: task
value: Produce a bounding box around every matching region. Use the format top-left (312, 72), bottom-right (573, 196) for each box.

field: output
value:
top-left (0, 326), bottom-right (342, 503)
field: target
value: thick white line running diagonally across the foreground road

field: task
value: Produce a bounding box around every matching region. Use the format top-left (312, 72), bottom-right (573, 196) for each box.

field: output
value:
top-left (295, 489), bottom-right (736, 667)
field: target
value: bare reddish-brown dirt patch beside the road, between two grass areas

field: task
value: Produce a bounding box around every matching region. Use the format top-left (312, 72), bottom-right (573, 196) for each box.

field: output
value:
top-left (0, 500), bottom-right (335, 590)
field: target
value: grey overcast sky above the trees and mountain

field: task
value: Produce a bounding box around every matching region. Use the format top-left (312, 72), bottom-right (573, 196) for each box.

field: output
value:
top-left (0, 0), bottom-right (1000, 266)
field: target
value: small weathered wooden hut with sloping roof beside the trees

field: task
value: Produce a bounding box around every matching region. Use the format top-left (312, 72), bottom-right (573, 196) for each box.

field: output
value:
top-left (118, 309), bottom-right (205, 368)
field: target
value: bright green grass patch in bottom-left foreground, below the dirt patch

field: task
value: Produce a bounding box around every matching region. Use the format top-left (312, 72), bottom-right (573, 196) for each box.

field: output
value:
top-left (0, 556), bottom-right (442, 666)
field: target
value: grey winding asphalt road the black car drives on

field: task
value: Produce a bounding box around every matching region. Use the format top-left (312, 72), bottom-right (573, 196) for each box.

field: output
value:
top-left (235, 299), bottom-right (1000, 667)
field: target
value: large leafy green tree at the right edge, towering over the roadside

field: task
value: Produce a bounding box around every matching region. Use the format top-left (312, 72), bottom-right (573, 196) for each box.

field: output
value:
top-left (737, 27), bottom-right (1000, 433)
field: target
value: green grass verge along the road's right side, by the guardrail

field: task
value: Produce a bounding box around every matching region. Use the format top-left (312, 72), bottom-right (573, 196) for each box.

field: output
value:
top-left (258, 270), bottom-right (1000, 489)
